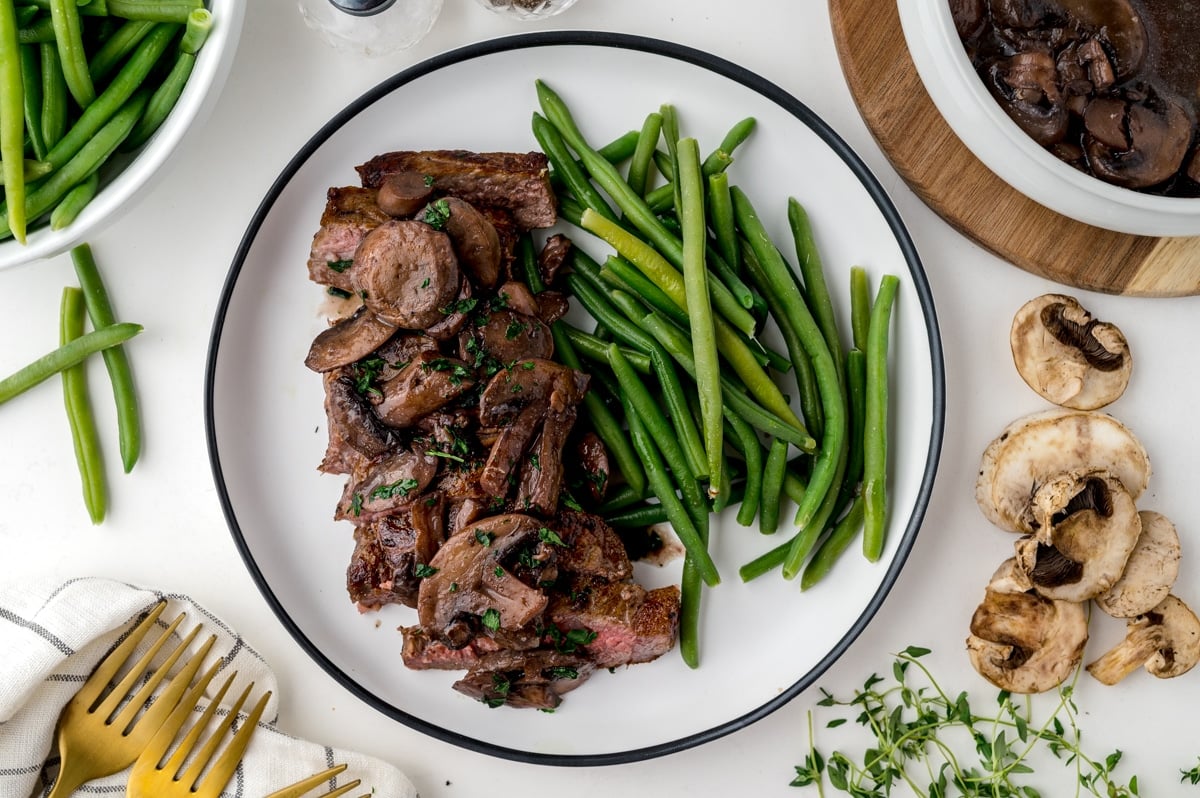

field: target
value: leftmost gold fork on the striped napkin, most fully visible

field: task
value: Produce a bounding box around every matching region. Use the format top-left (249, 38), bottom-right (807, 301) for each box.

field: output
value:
top-left (48, 601), bottom-right (216, 798)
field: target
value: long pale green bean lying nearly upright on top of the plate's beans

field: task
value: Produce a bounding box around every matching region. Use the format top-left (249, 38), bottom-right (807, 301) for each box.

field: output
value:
top-left (677, 137), bottom-right (725, 497)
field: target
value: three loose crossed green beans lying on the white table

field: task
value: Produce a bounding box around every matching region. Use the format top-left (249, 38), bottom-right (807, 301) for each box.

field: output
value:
top-left (0, 244), bottom-right (142, 524)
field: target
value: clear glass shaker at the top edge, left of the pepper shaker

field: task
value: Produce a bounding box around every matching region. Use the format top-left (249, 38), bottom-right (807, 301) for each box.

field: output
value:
top-left (299, 0), bottom-right (443, 55)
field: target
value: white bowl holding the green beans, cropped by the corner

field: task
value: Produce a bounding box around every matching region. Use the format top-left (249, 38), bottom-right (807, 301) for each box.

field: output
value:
top-left (0, 0), bottom-right (246, 269)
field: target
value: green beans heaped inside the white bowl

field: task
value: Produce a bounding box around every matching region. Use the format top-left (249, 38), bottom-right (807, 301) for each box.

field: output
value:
top-left (0, 0), bottom-right (214, 244)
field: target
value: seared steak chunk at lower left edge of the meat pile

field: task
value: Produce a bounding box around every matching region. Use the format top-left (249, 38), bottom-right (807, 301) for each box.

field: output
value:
top-left (346, 494), bottom-right (444, 610)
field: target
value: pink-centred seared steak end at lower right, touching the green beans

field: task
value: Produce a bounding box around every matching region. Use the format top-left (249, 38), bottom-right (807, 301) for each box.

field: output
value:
top-left (547, 582), bottom-right (679, 667)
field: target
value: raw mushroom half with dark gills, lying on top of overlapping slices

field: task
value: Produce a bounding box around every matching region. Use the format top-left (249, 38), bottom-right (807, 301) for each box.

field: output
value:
top-left (1015, 472), bottom-right (1141, 601)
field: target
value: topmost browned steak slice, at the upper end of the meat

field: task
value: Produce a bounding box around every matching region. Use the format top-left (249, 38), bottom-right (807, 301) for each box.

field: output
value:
top-left (358, 150), bottom-right (558, 229)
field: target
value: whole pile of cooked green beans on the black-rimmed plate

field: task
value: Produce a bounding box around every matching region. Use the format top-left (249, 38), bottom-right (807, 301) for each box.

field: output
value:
top-left (532, 80), bottom-right (899, 667)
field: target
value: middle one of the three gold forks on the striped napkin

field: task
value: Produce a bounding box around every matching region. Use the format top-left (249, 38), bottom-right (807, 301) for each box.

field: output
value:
top-left (126, 661), bottom-right (271, 798)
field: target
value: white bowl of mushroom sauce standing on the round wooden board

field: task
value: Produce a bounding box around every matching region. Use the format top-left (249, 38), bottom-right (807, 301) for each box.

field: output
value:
top-left (896, 0), bottom-right (1200, 236)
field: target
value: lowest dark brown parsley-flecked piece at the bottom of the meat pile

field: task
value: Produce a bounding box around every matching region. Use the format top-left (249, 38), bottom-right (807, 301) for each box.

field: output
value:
top-left (454, 649), bottom-right (595, 709)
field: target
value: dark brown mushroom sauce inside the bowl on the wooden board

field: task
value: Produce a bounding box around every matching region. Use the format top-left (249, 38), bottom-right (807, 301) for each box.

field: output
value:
top-left (949, 0), bottom-right (1200, 197)
